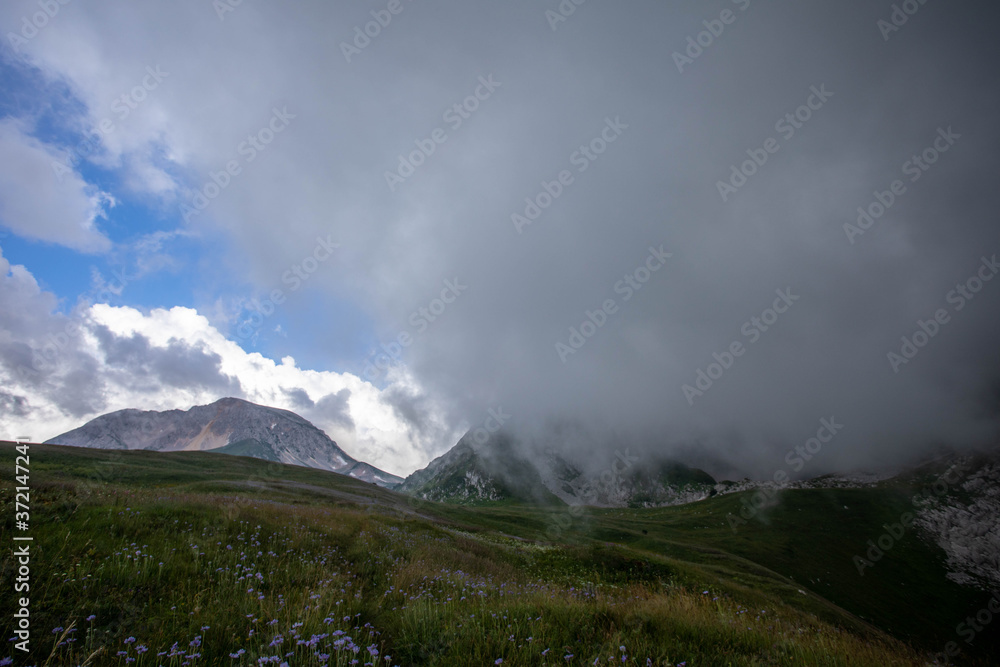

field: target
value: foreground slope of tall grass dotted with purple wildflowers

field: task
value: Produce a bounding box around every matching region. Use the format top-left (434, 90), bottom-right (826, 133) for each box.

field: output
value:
top-left (0, 482), bottom-right (923, 667)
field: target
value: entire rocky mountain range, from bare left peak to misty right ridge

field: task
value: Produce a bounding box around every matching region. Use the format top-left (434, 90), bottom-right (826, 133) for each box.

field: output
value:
top-left (41, 398), bottom-right (1000, 590)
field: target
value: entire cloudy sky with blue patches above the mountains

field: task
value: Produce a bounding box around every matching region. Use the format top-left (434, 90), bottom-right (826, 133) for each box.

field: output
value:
top-left (0, 0), bottom-right (1000, 476)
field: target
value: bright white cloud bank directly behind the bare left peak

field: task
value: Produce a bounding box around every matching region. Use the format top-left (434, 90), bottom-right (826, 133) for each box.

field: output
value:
top-left (0, 250), bottom-right (458, 475)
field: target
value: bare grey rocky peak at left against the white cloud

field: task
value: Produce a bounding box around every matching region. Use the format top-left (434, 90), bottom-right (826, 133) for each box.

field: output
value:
top-left (46, 398), bottom-right (403, 487)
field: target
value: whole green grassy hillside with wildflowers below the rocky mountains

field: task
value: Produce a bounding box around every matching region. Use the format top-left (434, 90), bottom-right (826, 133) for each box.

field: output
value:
top-left (0, 444), bottom-right (995, 667)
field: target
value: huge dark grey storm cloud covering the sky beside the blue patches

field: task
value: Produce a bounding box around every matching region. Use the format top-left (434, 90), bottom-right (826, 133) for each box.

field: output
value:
top-left (0, 0), bottom-right (1000, 476)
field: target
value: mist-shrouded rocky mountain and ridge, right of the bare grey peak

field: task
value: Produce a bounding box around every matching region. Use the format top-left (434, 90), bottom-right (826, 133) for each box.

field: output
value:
top-left (396, 432), bottom-right (1000, 590)
